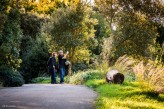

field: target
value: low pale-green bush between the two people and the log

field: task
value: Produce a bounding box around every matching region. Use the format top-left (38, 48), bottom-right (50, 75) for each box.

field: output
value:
top-left (70, 70), bottom-right (105, 84)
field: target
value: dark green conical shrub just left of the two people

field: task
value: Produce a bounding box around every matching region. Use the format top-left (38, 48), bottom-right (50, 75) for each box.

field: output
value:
top-left (20, 35), bottom-right (49, 82)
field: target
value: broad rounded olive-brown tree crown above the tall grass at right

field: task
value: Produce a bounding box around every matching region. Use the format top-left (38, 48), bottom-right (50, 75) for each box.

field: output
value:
top-left (111, 13), bottom-right (158, 59)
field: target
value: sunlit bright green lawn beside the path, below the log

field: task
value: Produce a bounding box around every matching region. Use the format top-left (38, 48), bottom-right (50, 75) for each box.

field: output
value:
top-left (85, 80), bottom-right (164, 109)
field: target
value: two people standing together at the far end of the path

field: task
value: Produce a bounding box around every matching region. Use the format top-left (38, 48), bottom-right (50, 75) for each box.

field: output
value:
top-left (47, 50), bottom-right (68, 84)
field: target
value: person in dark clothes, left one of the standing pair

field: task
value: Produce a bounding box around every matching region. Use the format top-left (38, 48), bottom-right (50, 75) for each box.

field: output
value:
top-left (47, 52), bottom-right (57, 84)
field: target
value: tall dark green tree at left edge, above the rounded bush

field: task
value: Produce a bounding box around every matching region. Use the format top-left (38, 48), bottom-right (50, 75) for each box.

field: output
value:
top-left (0, 9), bottom-right (22, 68)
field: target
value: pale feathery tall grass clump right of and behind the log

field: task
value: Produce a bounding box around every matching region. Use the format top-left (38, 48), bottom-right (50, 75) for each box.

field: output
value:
top-left (111, 55), bottom-right (164, 93)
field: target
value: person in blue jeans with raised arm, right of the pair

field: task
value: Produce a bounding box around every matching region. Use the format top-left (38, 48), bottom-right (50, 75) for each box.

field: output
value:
top-left (58, 50), bottom-right (68, 84)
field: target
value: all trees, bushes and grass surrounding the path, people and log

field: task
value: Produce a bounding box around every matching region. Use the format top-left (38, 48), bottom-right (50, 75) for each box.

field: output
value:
top-left (0, 0), bottom-right (164, 109)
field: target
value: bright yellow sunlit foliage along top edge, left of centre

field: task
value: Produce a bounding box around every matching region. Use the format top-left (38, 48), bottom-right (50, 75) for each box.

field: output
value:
top-left (21, 0), bottom-right (80, 14)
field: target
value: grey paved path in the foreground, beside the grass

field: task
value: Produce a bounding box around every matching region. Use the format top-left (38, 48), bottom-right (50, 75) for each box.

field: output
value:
top-left (0, 84), bottom-right (97, 109)
